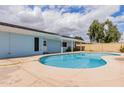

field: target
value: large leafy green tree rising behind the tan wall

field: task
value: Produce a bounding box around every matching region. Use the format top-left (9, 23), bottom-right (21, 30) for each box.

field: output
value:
top-left (88, 19), bottom-right (121, 43)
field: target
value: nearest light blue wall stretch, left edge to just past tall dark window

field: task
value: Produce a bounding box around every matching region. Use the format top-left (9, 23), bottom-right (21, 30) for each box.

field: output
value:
top-left (0, 32), bottom-right (43, 58)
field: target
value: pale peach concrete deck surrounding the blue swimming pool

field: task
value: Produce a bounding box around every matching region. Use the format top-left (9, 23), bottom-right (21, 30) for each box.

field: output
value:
top-left (0, 52), bottom-right (124, 87)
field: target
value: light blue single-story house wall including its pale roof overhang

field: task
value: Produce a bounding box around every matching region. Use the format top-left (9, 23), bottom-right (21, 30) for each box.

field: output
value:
top-left (0, 24), bottom-right (81, 58)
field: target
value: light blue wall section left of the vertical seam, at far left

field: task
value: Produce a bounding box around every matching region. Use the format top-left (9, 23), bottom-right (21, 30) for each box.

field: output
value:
top-left (0, 32), bottom-right (10, 58)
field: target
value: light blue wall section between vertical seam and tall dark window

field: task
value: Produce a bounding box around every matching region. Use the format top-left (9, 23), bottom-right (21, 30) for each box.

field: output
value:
top-left (11, 34), bottom-right (42, 56)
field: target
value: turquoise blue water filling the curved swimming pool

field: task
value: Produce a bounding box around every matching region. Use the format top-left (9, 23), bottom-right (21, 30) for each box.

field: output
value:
top-left (40, 53), bottom-right (118, 68)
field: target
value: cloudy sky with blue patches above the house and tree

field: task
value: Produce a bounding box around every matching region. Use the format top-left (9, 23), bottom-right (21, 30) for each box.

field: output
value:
top-left (0, 5), bottom-right (124, 41)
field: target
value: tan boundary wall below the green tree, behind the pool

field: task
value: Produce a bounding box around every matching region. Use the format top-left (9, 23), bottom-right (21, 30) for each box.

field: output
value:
top-left (77, 43), bottom-right (124, 52)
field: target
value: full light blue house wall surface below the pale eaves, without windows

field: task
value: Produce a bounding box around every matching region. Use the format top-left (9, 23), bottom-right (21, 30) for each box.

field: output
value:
top-left (0, 32), bottom-right (76, 58)
